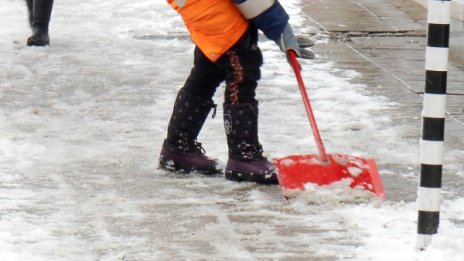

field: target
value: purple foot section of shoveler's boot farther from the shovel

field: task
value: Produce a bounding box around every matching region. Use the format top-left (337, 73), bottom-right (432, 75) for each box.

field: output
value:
top-left (159, 140), bottom-right (222, 174)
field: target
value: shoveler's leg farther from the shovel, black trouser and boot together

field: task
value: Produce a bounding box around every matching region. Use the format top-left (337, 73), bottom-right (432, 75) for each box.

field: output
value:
top-left (160, 48), bottom-right (224, 174)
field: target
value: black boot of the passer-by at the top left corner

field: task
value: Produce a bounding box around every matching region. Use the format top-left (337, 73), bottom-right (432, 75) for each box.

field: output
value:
top-left (27, 0), bottom-right (53, 46)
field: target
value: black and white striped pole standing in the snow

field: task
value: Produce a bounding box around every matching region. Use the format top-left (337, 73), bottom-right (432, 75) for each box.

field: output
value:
top-left (417, 0), bottom-right (451, 250)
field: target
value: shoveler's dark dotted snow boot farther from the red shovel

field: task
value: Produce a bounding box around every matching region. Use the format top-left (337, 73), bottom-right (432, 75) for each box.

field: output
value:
top-left (159, 89), bottom-right (222, 174)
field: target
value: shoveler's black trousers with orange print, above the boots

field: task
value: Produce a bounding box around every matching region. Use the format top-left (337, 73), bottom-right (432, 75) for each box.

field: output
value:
top-left (183, 25), bottom-right (263, 104)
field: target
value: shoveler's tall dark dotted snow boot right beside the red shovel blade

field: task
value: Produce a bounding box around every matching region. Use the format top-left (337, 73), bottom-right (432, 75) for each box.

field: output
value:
top-left (224, 102), bottom-right (278, 184)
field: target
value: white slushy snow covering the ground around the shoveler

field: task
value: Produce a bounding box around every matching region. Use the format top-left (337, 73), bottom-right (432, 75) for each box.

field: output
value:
top-left (0, 0), bottom-right (464, 261)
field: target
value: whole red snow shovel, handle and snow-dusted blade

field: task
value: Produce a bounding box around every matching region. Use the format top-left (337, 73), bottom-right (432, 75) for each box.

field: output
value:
top-left (274, 50), bottom-right (384, 197)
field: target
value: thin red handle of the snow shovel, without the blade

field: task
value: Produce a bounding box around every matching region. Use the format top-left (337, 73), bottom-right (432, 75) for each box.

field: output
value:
top-left (287, 50), bottom-right (328, 162)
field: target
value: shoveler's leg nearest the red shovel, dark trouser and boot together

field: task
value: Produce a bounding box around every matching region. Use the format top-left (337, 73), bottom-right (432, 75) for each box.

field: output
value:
top-left (220, 23), bottom-right (277, 184)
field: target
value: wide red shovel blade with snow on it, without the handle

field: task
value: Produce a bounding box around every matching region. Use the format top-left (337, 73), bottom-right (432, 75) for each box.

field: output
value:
top-left (274, 154), bottom-right (385, 197)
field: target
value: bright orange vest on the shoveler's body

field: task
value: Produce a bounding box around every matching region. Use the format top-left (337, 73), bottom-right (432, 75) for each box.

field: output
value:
top-left (166, 0), bottom-right (248, 62)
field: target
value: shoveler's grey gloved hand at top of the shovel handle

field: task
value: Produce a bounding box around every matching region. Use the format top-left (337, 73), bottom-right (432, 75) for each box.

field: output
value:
top-left (275, 24), bottom-right (314, 59)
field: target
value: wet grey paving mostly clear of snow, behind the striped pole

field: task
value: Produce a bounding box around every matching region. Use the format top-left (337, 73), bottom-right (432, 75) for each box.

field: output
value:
top-left (304, 0), bottom-right (464, 195)
